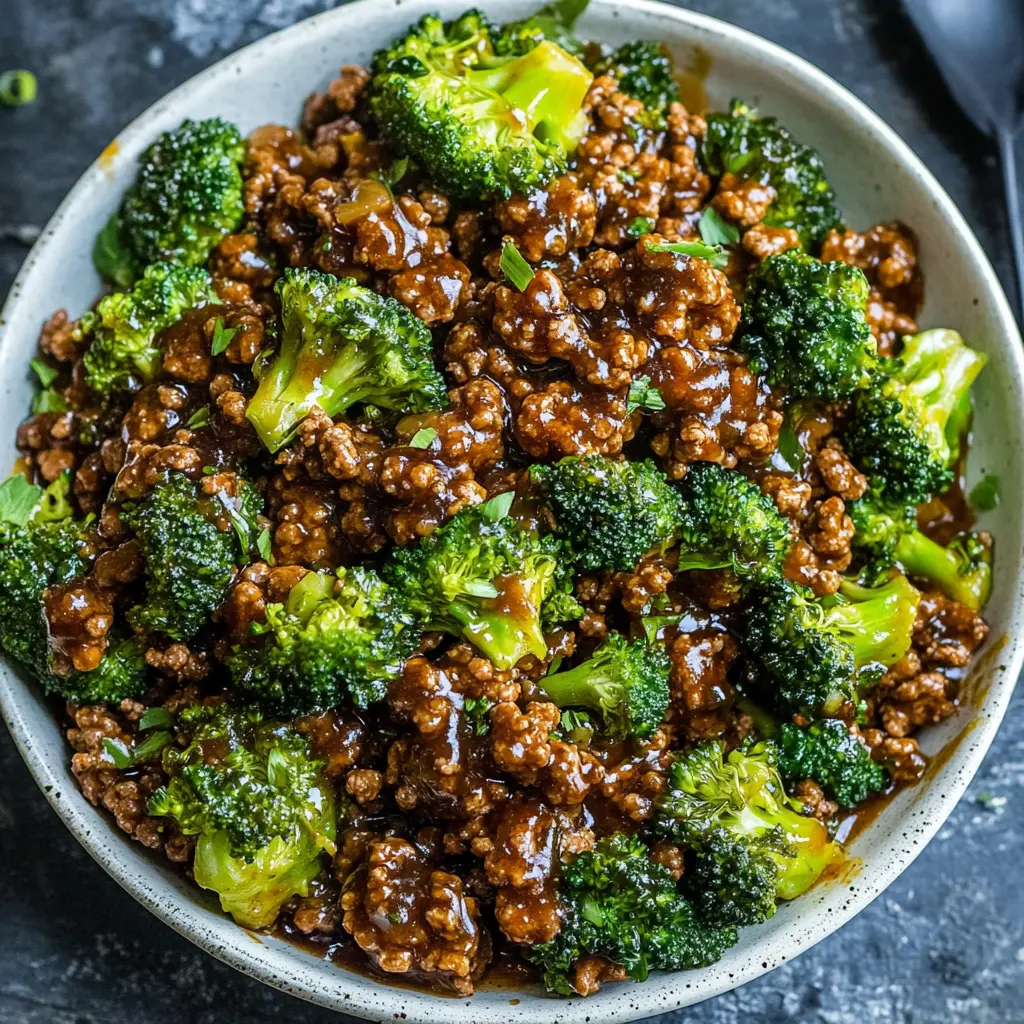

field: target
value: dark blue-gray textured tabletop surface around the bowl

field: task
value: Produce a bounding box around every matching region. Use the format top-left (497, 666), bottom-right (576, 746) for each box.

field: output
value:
top-left (0, 0), bottom-right (1024, 1024)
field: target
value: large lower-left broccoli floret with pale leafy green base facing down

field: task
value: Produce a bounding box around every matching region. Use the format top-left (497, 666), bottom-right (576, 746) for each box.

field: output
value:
top-left (146, 703), bottom-right (335, 928)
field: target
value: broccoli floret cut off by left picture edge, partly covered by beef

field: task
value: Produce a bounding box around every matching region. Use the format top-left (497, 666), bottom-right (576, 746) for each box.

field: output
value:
top-left (0, 476), bottom-right (147, 703)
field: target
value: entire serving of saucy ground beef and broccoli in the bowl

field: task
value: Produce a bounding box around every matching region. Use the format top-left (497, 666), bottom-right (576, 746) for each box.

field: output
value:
top-left (0, 0), bottom-right (991, 994)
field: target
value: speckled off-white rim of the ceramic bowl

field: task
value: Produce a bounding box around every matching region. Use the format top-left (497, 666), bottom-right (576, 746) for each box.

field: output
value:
top-left (0, 0), bottom-right (1024, 1024)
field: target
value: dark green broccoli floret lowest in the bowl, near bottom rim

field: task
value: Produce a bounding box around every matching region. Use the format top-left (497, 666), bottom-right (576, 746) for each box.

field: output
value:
top-left (524, 833), bottom-right (736, 995)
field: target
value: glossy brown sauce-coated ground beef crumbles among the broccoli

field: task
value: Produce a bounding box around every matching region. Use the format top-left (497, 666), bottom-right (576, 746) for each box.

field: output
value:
top-left (17, 59), bottom-right (987, 993)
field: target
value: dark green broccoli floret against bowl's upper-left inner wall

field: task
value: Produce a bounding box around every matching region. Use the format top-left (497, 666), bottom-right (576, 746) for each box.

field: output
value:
top-left (92, 118), bottom-right (246, 288)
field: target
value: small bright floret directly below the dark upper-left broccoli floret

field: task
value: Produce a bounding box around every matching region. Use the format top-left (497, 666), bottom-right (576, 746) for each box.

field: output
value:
top-left (76, 263), bottom-right (220, 398)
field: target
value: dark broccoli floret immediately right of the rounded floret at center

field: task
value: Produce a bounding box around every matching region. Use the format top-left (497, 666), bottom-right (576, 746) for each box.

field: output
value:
top-left (679, 462), bottom-right (792, 589)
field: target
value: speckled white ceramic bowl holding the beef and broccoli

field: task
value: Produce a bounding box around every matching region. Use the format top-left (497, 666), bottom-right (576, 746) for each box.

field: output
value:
top-left (0, 0), bottom-right (1024, 1024)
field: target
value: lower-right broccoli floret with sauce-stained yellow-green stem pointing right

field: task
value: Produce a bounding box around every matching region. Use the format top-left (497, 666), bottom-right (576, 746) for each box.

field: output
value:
top-left (651, 740), bottom-right (842, 925)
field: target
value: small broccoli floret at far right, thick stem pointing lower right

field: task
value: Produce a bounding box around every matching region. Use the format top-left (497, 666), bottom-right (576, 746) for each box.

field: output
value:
top-left (847, 490), bottom-right (992, 611)
